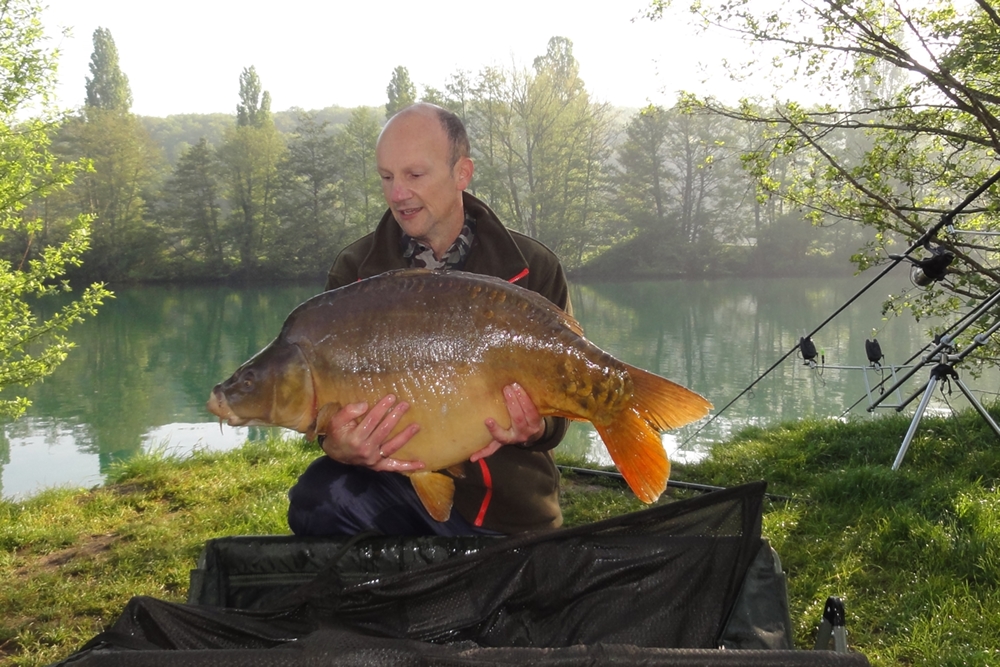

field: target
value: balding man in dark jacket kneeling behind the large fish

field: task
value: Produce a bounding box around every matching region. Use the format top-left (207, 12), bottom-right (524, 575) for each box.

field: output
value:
top-left (288, 104), bottom-right (569, 535)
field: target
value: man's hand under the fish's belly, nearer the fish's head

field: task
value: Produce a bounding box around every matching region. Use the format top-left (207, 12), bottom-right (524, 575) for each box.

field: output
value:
top-left (323, 394), bottom-right (424, 472)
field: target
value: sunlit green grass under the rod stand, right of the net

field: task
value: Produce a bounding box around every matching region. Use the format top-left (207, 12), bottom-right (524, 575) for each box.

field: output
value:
top-left (675, 411), bottom-right (1000, 665)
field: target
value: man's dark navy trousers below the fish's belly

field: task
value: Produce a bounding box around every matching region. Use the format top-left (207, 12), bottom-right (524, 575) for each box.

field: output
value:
top-left (288, 456), bottom-right (498, 537)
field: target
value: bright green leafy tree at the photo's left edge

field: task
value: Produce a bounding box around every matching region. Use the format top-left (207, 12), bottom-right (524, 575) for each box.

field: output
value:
top-left (0, 0), bottom-right (110, 417)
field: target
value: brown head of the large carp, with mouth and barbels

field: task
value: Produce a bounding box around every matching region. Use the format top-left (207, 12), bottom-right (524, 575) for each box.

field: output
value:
top-left (208, 338), bottom-right (315, 433)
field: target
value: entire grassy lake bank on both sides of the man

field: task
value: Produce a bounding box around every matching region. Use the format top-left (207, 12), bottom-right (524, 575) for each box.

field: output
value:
top-left (0, 413), bottom-right (1000, 665)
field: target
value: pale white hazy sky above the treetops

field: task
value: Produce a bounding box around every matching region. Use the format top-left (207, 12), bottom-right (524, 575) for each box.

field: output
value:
top-left (42, 0), bottom-right (752, 116)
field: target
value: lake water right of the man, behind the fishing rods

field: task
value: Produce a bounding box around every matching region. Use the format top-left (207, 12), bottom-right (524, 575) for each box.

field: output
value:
top-left (572, 279), bottom-right (997, 460)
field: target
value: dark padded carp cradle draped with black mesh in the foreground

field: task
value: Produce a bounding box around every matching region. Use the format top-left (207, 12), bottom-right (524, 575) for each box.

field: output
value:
top-left (52, 483), bottom-right (867, 667)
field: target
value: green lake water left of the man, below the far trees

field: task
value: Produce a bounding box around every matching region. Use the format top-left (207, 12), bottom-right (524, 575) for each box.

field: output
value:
top-left (0, 285), bottom-right (315, 496)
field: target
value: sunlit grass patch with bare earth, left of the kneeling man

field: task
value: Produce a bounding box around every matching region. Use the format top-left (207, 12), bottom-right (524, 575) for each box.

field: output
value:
top-left (0, 439), bottom-right (317, 665)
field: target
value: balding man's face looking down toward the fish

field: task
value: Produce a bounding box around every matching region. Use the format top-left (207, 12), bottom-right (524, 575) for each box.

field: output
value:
top-left (375, 112), bottom-right (472, 257)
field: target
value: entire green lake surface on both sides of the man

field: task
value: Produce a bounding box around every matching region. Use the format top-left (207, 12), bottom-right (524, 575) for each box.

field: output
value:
top-left (0, 276), bottom-right (997, 498)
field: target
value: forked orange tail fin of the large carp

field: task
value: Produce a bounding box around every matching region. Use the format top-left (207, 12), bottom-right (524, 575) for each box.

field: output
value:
top-left (594, 366), bottom-right (712, 503)
